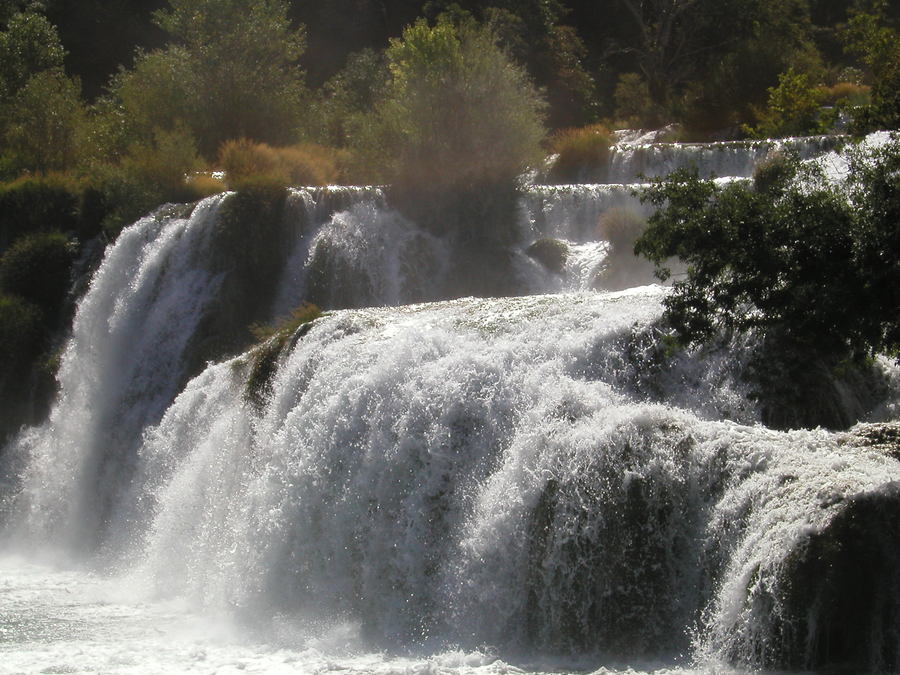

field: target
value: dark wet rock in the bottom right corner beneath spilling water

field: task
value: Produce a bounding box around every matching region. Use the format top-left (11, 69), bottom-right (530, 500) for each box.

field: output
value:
top-left (758, 483), bottom-right (900, 673)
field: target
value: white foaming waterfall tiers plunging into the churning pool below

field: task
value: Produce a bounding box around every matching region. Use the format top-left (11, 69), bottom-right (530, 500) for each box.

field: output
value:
top-left (0, 135), bottom-right (900, 672)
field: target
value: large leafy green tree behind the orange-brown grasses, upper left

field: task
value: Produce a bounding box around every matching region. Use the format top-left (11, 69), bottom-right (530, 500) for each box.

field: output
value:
top-left (111, 0), bottom-right (306, 157)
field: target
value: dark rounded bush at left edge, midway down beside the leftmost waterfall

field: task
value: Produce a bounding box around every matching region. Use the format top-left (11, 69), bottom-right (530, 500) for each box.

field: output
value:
top-left (0, 232), bottom-right (73, 317)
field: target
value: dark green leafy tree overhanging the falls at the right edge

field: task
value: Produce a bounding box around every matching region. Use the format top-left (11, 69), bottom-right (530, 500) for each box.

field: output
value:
top-left (635, 142), bottom-right (900, 426)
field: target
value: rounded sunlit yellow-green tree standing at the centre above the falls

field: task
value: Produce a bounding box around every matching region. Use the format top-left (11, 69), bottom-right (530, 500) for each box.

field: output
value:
top-left (363, 18), bottom-right (544, 201)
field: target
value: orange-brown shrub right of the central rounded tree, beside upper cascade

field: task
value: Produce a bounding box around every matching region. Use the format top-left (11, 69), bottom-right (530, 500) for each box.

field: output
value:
top-left (548, 124), bottom-right (612, 183)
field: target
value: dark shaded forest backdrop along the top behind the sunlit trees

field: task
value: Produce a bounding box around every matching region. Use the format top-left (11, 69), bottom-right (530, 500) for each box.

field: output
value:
top-left (2, 0), bottom-right (900, 132)
